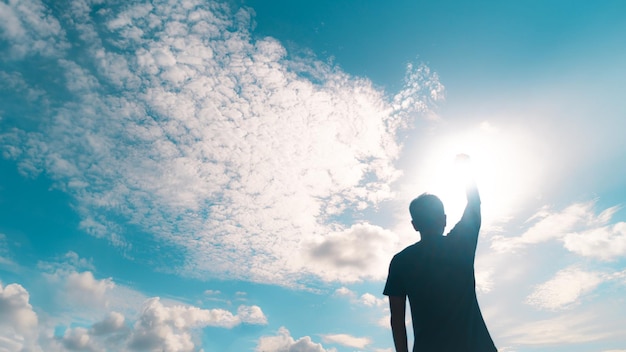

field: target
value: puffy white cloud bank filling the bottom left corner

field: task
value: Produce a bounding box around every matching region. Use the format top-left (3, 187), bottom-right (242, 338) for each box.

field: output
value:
top-left (0, 252), bottom-right (268, 352)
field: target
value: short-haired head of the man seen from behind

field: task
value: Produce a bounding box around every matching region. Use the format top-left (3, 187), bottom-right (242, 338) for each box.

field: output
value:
top-left (409, 193), bottom-right (446, 237)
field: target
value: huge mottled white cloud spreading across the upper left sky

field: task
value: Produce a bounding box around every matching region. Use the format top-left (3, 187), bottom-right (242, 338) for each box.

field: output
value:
top-left (0, 2), bottom-right (443, 284)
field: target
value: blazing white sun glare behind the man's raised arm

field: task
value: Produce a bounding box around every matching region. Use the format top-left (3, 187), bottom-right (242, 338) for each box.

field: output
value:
top-left (410, 121), bottom-right (538, 231)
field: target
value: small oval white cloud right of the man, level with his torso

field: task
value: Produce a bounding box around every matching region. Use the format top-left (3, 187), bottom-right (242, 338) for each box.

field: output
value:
top-left (526, 267), bottom-right (603, 310)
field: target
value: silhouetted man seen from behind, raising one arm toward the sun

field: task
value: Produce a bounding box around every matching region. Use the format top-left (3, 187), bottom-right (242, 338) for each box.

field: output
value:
top-left (383, 155), bottom-right (497, 352)
